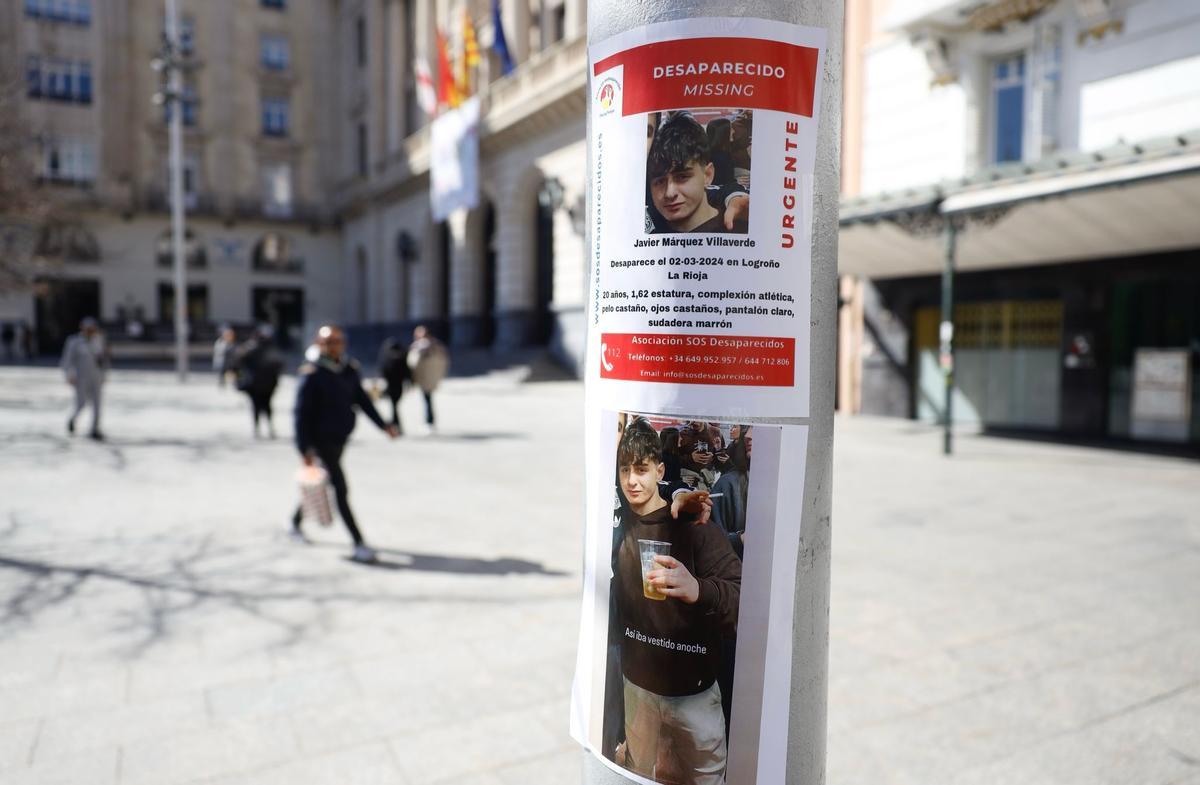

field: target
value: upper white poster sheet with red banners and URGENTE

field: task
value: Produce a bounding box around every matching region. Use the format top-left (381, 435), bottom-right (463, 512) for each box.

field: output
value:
top-left (587, 19), bottom-right (824, 417)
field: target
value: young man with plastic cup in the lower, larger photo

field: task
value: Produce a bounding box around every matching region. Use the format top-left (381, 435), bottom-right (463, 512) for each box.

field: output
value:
top-left (612, 418), bottom-right (742, 785)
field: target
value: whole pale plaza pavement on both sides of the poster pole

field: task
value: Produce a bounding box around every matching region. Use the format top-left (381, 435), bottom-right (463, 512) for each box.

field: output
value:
top-left (0, 368), bottom-right (1200, 785)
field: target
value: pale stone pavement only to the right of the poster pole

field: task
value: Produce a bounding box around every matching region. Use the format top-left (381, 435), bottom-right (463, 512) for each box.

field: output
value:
top-left (829, 420), bottom-right (1200, 785)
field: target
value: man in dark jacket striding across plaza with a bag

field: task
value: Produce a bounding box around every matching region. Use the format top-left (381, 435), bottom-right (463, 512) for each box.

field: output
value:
top-left (292, 324), bottom-right (400, 562)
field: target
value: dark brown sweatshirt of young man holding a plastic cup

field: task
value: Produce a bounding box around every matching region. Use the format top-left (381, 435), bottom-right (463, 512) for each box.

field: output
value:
top-left (613, 505), bottom-right (742, 697)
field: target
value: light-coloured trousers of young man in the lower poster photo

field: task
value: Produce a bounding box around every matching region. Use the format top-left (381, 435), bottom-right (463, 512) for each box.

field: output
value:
top-left (625, 679), bottom-right (727, 785)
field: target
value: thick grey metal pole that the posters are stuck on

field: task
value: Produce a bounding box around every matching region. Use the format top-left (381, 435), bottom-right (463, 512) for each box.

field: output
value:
top-left (583, 0), bottom-right (844, 785)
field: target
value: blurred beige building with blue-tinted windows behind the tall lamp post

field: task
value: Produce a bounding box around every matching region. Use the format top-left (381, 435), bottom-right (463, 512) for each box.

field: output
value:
top-left (0, 0), bottom-right (343, 353)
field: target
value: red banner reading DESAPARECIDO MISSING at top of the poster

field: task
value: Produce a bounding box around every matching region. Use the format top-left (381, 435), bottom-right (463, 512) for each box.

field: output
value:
top-left (593, 37), bottom-right (818, 118)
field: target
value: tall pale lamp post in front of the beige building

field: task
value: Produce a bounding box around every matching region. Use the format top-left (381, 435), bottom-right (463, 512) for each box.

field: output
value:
top-left (166, 0), bottom-right (187, 382)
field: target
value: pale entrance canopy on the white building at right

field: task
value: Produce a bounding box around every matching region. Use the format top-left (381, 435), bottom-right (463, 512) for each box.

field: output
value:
top-left (838, 130), bottom-right (1200, 278)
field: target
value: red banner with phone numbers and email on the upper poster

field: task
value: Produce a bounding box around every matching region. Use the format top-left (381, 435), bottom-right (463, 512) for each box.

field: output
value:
top-left (600, 332), bottom-right (796, 386)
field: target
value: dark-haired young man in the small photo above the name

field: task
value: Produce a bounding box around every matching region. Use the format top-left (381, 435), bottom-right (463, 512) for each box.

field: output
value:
top-left (646, 112), bottom-right (749, 234)
